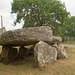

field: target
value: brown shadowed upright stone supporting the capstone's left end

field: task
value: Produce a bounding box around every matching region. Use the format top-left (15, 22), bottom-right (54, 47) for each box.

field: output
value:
top-left (1, 46), bottom-right (18, 63)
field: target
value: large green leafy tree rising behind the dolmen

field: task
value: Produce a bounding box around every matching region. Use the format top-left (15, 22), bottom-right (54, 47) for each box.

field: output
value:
top-left (12, 0), bottom-right (69, 35)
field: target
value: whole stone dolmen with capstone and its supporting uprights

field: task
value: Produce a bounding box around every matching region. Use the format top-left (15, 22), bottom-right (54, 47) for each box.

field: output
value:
top-left (0, 26), bottom-right (67, 67)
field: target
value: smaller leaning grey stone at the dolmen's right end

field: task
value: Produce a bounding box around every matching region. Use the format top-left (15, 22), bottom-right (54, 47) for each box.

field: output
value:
top-left (53, 44), bottom-right (68, 59)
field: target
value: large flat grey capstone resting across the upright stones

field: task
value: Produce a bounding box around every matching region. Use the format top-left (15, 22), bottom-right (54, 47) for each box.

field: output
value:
top-left (0, 26), bottom-right (62, 46)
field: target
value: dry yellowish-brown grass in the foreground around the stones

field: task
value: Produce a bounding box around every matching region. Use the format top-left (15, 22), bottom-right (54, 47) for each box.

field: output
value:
top-left (0, 48), bottom-right (75, 75)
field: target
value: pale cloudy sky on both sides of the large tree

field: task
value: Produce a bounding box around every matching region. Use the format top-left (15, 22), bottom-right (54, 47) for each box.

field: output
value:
top-left (0, 0), bottom-right (75, 31)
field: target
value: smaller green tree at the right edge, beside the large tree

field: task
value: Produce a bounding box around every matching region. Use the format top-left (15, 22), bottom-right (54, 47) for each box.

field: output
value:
top-left (64, 16), bottom-right (75, 37)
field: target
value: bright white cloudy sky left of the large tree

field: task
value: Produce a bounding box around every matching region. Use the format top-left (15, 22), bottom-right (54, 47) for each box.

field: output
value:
top-left (0, 0), bottom-right (23, 30)
